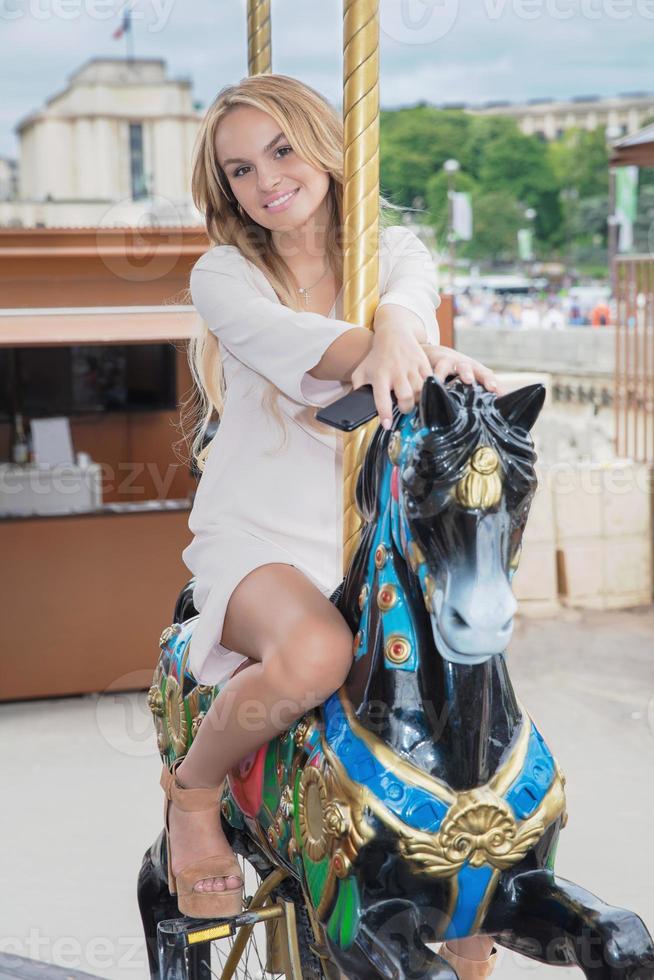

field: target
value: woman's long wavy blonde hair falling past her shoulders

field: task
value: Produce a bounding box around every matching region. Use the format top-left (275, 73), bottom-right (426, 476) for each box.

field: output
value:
top-left (181, 73), bottom-right (414, 472)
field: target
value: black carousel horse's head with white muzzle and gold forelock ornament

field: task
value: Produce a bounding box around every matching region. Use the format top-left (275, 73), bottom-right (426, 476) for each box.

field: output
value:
top-left (357, 376), bottom-right (545, 664)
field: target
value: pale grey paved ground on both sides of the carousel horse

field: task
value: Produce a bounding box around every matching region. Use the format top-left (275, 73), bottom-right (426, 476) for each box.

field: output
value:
top-left (0, 607), bottom-right (654, 980)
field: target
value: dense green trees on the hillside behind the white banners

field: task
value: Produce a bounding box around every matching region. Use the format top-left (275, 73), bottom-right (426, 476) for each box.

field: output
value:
top-left (380, 103), bottom-right (636, 261)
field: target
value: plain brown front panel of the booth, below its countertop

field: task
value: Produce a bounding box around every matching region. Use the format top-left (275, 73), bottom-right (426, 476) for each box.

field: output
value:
top-left (0, 501), bottom-right (192, 701)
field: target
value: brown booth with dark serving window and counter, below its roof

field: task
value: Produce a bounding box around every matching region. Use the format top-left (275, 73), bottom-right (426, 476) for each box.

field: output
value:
top-left (0, 306), bottom-right (196, 701)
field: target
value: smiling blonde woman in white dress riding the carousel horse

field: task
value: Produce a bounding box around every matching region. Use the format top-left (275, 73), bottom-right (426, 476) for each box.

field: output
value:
top-left (161, 74), bottom-right (498, 976)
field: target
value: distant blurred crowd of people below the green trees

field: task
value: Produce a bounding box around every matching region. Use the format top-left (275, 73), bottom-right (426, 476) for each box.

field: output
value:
top-left (454, 289), bottom-right (614, 330)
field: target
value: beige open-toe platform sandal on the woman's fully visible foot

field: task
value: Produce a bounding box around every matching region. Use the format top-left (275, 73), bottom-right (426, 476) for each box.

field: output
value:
top-left (159, 756), bottom-right (244, 919)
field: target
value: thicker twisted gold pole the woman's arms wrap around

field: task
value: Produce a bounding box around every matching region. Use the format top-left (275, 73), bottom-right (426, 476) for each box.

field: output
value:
top-left (343, 0), bottom-right (379, 574)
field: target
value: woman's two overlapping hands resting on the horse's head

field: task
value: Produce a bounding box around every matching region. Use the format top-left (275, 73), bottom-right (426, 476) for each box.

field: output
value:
top-left (351, 323), bottom-right (501, 429)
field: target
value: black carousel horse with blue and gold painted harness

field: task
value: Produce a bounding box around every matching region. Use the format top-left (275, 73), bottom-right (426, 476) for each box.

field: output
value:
top-left (144, 377), bottom-right (654, 980)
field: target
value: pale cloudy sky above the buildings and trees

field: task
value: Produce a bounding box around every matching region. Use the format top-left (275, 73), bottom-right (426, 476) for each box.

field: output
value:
top-left (0, 0), bottom-right (654, 157)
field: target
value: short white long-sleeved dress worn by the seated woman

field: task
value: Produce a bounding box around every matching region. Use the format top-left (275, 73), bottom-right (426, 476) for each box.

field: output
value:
top-left (182, 226), bottom-right (440, 684)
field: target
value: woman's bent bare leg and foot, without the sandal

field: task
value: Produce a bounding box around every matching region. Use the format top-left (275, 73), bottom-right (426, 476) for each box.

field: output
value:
top-left (169, 563), bottom-right (353, 891)
